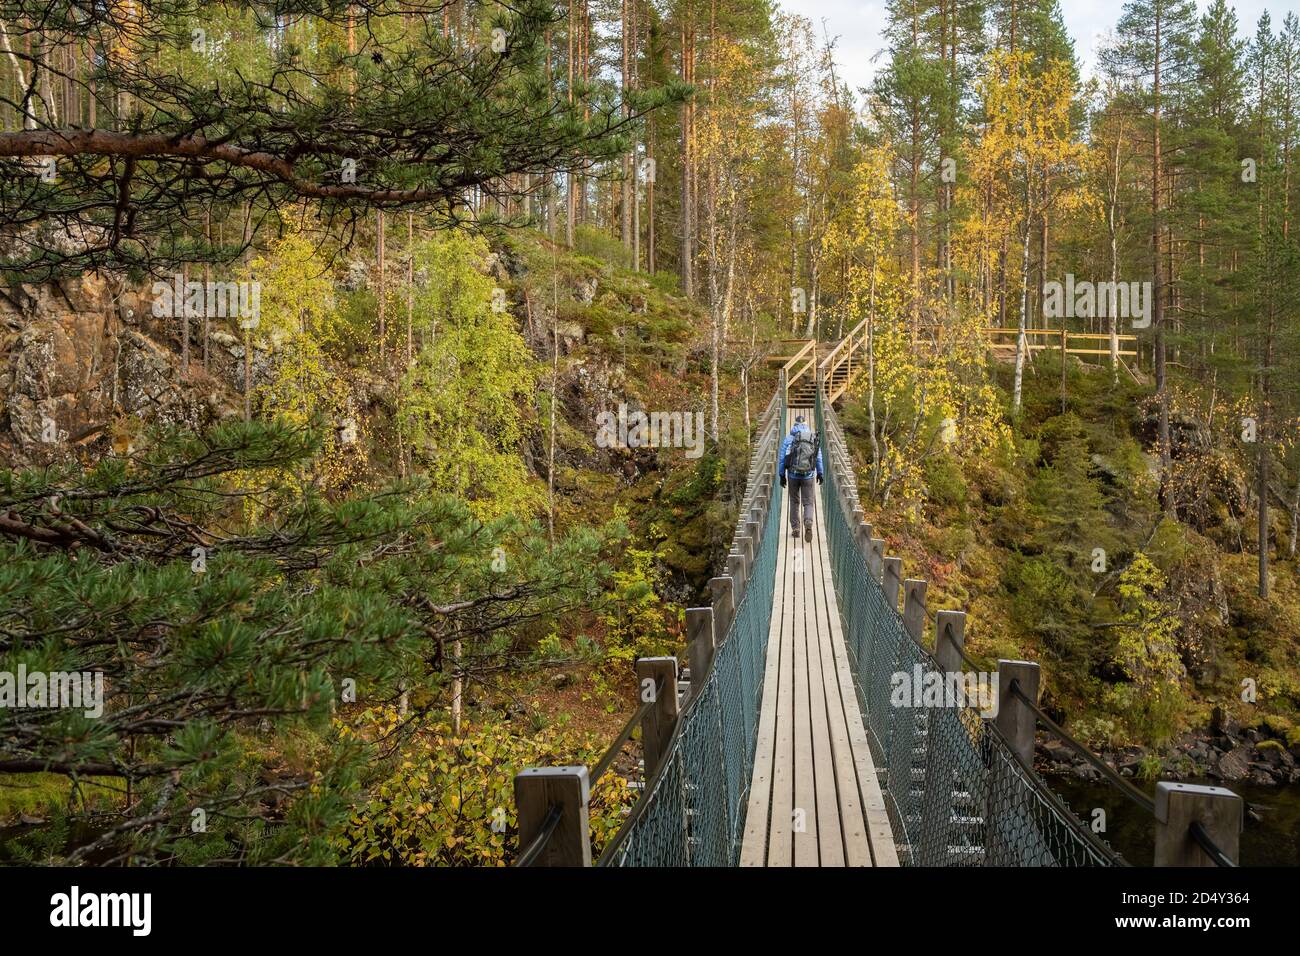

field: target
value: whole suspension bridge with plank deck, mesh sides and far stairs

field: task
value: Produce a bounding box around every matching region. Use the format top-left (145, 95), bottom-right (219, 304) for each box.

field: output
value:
top-left (515, 325), bottom-right (1243, 866)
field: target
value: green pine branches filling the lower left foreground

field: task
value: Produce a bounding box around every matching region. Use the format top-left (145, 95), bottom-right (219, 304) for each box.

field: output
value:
top-left (0, 421), bottom-right (616, 864)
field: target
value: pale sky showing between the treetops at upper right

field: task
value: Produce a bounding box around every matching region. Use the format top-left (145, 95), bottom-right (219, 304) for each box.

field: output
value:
top-left (777, 0), bottom-right (1300, 98)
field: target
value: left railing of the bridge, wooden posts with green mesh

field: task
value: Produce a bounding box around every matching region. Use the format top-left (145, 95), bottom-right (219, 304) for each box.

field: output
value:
top-left (515, 389), bottom-right (785, 866)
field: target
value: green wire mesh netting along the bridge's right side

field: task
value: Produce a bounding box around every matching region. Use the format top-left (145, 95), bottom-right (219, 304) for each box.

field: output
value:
top-left (816, 395), bottom-right (1123, 866)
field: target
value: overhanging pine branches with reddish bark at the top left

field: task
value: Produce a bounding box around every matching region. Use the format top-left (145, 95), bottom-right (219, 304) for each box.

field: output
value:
top-left (0, 0), bottom-right (683, 280)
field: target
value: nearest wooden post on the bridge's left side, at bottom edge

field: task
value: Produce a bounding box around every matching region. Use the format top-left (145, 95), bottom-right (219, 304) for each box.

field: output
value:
top-left (515, 767), bottom-right (592, 866)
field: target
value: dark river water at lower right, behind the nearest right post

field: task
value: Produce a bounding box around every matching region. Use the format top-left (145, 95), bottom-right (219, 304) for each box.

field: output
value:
top-left (1045, 775), bottom-right (1300, 866)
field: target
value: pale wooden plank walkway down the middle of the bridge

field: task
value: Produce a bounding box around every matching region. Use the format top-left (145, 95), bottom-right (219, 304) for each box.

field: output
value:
top-left (740, 410), bottom-right (898, 866)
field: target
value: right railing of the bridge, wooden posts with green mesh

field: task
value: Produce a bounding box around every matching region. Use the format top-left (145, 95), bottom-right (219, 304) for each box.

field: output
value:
top-left (815, 379), bottom-right (1242, 866)
